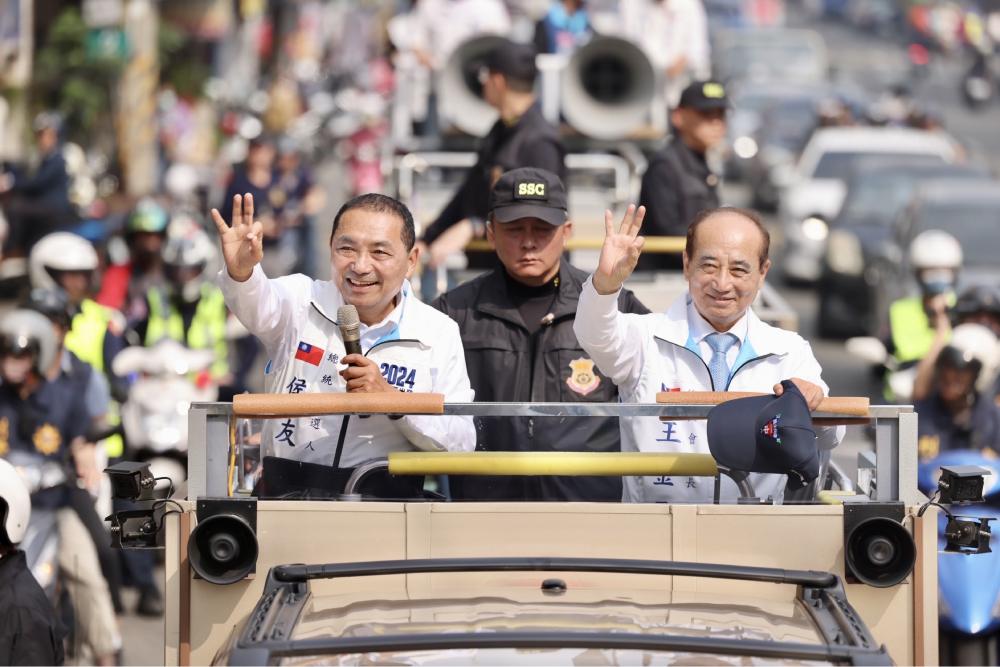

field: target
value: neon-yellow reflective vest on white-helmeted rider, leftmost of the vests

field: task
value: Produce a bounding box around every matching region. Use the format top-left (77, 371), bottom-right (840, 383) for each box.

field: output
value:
top-left (63, 299), bottom-right (126, 458)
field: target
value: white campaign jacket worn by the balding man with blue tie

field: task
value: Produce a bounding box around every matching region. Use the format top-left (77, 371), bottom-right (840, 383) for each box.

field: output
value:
top-left (574, 277), bottom-right (845, 503)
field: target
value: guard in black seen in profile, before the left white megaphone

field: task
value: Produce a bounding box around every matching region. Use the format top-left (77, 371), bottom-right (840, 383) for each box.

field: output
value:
top-left (420, 40), bottom-right (566, 268)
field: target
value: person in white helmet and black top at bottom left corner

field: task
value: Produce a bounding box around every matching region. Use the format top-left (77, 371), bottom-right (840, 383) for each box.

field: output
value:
top-left (0, 459), bottom-right (68, 665)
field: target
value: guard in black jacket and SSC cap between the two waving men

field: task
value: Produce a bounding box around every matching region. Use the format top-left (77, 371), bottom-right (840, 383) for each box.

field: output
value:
top-left (431, 167), bottom-right (649, 502)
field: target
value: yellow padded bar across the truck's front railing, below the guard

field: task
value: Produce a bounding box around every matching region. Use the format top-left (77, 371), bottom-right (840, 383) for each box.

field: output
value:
top-left (389, 452), bottom-right (718, 477)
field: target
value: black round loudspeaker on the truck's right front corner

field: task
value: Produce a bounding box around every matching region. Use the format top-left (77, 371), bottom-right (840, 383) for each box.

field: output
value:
top-left (844, 502), bottom-right (917, 588)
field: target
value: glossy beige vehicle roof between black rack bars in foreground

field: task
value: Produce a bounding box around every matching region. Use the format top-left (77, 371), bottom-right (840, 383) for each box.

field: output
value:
top-left (281, 588), bottom-right (828, 666)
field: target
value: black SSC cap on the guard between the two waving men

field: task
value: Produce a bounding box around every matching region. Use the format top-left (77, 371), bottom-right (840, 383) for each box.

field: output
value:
top-left (488, 167), bottom-right (567, 226)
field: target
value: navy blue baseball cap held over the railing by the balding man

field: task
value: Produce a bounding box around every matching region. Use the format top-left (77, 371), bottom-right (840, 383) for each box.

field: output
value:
top-left (708, 380), bottom-right (819, 489)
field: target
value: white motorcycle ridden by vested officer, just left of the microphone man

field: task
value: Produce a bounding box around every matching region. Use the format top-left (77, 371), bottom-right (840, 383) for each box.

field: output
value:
top-left (112, 339), bottom-right (218, 489)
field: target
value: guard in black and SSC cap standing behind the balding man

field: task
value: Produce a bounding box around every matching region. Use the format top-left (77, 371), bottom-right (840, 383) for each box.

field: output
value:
top-left (636, 81), bottom-right (729, 271)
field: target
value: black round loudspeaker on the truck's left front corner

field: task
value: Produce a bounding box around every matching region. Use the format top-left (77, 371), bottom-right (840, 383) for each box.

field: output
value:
top-left (188, 498), bottom-right (257, 584)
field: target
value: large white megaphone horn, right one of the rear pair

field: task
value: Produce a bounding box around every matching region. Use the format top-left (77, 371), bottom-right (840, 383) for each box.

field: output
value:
top-left (561, 37), bottom-right (656, 139)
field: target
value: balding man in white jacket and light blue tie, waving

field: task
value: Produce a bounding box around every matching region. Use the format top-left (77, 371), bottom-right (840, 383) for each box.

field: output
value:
top-left (574, 206), bottom-right (844, 503)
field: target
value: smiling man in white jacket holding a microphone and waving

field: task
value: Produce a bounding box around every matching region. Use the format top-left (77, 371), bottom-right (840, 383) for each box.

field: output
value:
top-left (212, 194), bottom-right (476, 497)
